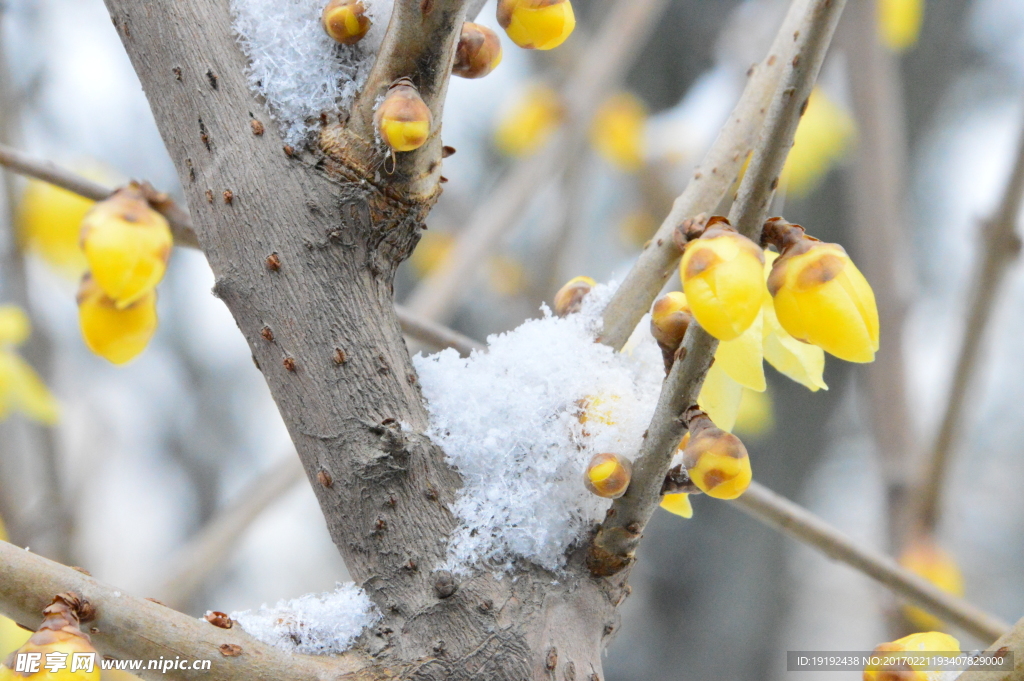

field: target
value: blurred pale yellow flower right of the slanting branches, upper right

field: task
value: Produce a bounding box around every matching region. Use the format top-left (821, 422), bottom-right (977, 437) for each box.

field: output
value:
top-left (780, 88), bottom-right (855, 197)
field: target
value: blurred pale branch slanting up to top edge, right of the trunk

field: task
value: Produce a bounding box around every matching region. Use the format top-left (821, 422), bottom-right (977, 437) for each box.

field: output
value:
top-left (406, 0), bottom-right (668, 321)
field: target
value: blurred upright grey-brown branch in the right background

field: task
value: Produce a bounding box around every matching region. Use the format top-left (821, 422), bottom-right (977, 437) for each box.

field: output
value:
top-left (839, 2), bottom-right (919, 554)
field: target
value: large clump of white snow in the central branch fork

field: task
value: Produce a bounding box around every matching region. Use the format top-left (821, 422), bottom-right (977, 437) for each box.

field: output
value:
top-left (414, 286), bottom-right (665, 572)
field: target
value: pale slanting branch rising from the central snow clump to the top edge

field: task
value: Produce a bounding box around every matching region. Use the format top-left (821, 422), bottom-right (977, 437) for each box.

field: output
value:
top-left (601, 0), bottom-right (813, 349)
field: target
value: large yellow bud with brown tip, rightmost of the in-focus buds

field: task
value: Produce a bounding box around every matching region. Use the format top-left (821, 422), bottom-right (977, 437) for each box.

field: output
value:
top-left (765, 218), bottom-right (879, 363)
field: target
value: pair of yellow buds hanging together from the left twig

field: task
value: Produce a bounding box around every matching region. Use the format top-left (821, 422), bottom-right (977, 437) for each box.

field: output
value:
top-left (78, 182), bottom-right (173, 365)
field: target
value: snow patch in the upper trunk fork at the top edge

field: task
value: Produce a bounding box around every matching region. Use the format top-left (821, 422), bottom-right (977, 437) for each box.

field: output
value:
top-left (231, 0), bottom-right (394, 144)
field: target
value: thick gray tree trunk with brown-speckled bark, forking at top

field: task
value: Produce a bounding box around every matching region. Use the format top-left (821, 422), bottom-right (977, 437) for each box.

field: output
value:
top-left (99, 0), bottom-right (625, 681)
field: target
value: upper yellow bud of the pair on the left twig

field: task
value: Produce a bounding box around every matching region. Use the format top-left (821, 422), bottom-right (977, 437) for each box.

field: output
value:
top-left (82, 182), bottom-right (173, 307)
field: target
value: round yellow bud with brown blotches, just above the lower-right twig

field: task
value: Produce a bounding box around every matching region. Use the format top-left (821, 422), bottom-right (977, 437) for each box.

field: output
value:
top-left (683, 412), bottom-right (753, 499)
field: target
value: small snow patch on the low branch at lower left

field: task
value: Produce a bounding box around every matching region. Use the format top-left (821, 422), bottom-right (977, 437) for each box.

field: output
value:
top-left (230, 582), bottom-right (380, 655)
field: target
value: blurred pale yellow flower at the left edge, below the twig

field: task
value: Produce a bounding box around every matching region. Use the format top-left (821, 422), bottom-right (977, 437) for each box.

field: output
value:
top-left (0, 305), bottom-right (59, 424)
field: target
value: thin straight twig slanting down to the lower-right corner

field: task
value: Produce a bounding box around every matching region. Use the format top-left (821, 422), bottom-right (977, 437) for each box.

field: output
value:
top-left (732, 481), bottom-right (1010, 641)
